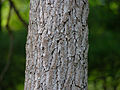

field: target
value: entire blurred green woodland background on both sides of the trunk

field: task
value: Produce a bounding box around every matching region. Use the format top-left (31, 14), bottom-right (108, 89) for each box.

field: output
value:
top-left (0, 0), bottom-right (120, 90)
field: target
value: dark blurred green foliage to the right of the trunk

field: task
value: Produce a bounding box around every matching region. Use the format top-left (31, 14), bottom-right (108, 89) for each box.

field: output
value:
top-left (88, 0), bottom-right (120, 90)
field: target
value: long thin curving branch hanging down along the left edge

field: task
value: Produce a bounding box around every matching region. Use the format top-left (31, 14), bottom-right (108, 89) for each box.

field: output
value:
top-left (0, 5), bottom-right (13, 83)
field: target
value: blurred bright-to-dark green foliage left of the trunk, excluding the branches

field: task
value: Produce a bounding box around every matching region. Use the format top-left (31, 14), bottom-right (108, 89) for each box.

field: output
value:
top-left (0, 0), bottom-right (29, 90)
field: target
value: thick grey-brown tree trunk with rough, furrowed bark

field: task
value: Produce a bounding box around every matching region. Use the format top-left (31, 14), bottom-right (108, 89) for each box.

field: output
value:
top-left (24, 0), bottom-right (88, 90)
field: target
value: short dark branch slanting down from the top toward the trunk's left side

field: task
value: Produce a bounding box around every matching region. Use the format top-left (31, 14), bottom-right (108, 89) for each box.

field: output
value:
top-left (9, 0), bottom-right (28, 28)
